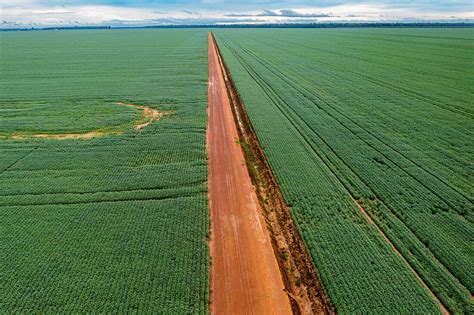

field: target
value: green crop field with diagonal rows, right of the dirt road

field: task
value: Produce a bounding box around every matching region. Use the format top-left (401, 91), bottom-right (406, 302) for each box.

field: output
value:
top-left (215, 28), bottom-right (474, 314)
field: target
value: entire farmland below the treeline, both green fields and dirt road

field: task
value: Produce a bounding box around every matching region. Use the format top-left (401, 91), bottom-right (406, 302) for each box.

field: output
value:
top-left (0, 28), bottom-right (474, 314)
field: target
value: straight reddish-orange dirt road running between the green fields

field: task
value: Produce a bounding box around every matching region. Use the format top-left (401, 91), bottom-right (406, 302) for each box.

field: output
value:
top-left (207, 33), bottom-right (291, 314)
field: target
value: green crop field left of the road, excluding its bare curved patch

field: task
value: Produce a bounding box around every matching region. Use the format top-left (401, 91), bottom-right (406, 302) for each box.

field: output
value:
top-left (0, 30), bottom-right (209, 314)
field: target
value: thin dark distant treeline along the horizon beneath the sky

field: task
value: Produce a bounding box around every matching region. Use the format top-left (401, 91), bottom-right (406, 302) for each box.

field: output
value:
top-left (0, 22), bottom-right (474, 31)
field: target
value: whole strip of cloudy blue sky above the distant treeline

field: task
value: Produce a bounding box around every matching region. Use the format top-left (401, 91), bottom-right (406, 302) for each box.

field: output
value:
top-left (0, 0), bottom-right (474, 28)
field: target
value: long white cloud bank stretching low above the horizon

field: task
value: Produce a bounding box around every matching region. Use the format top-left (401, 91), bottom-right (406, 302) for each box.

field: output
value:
top-left (0, 0), bottom-right (474, 27)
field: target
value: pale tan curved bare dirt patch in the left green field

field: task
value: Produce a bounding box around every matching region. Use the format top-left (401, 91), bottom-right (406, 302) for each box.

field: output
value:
top-left (6, 102), bottom-right (167, 140)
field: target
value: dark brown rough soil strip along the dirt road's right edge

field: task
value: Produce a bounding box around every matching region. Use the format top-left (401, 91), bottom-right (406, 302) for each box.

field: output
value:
top-left (211, 33), bottom-right (335, 314)
